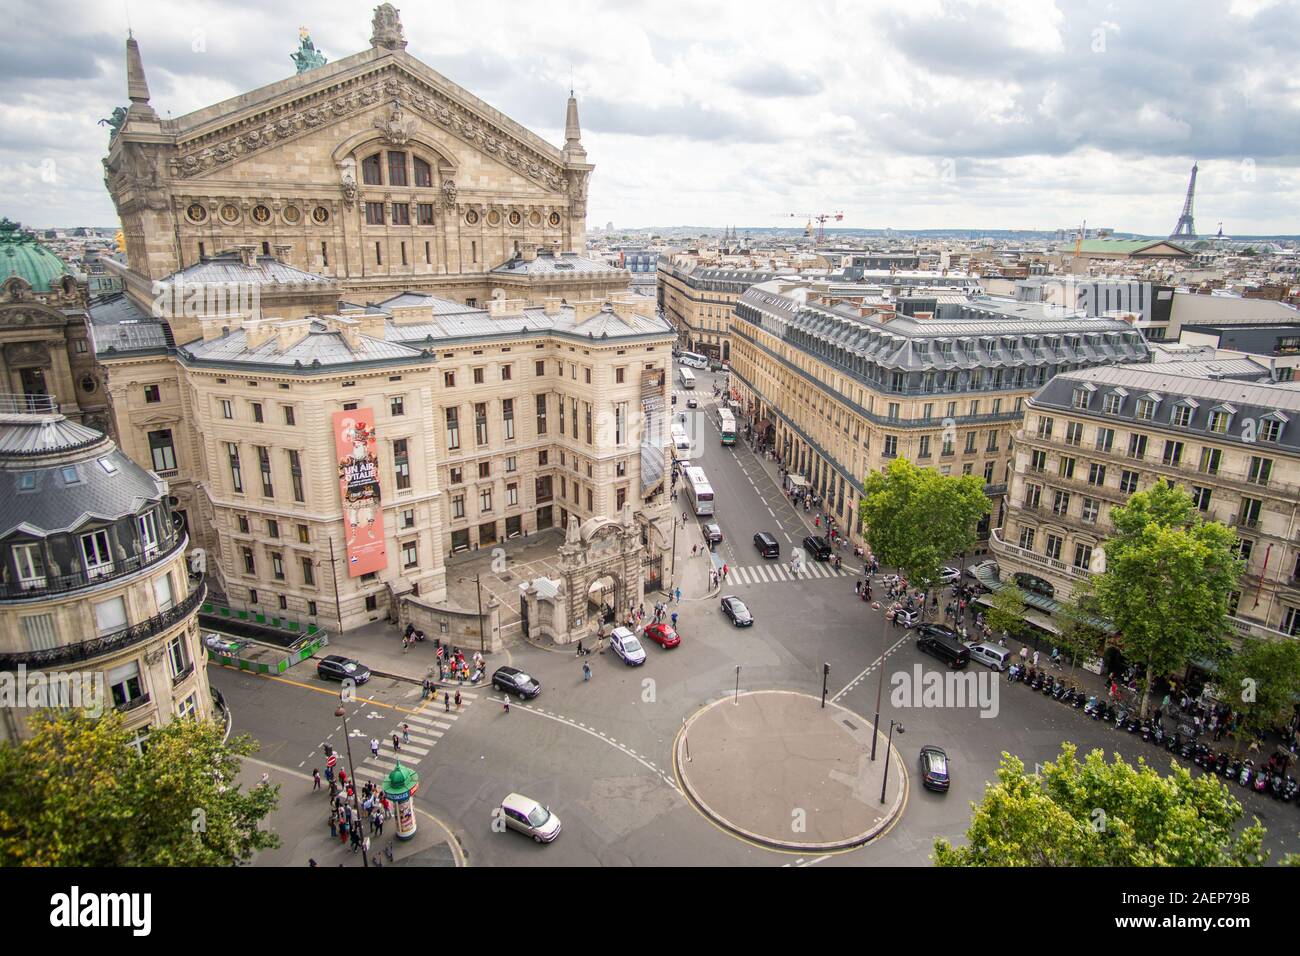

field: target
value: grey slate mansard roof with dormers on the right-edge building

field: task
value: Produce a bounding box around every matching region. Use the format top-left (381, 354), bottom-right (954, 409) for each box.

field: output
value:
top-left (1030, 362), bottom-right (1300, 455)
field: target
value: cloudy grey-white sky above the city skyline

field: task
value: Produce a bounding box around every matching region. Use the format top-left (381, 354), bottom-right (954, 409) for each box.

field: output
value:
top-left (0, 0), bottom-right (1300, 235)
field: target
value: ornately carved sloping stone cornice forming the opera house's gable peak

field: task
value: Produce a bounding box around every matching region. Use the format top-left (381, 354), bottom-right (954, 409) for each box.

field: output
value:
top-left (164, 49), bottom-right (568, 194)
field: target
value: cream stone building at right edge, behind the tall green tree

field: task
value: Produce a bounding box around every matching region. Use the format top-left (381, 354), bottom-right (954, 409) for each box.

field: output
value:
top-left (991, 359), bottom-right (1300, 637)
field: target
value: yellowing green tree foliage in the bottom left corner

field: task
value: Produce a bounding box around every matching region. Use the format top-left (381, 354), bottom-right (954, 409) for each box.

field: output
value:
top-left (0, 710), bottom-right (280, 866)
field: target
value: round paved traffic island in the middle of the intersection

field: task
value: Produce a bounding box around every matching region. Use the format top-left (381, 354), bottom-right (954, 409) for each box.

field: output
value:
top-left (673, 691), bottom-right (907, 852)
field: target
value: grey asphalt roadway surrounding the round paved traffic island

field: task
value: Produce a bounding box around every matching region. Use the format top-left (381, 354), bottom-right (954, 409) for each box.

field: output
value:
top-left (212, 364), bottom-right (1300, 866)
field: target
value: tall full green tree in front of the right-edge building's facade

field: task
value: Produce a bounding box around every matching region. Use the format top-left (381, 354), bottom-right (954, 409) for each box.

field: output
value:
top-left (1089, 481), bottom-right (1242, 717)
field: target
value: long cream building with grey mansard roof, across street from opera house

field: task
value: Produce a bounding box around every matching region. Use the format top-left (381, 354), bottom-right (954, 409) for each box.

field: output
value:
top-left (731, 280), bottom-right (1149, 540)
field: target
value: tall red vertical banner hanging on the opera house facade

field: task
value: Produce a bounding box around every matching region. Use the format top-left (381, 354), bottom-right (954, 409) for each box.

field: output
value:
top-left (334, 408), bottom-right (389, 578)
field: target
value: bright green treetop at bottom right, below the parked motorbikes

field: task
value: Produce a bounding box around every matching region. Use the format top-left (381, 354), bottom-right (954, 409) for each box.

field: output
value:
top-left (932, 744), bottom-right (1268, 866)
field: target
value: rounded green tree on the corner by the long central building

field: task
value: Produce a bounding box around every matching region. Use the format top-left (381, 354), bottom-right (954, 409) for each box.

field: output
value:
top-left (858, 458), bottom-right (989, 591)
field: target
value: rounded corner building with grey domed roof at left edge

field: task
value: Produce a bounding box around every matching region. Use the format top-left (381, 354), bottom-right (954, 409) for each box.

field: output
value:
top-left (0, 394), bottom-right (212, 748)
